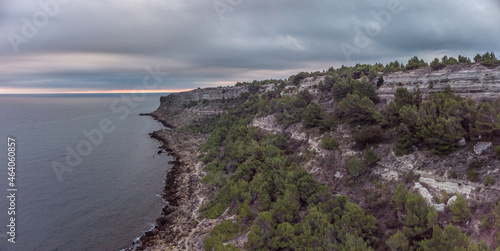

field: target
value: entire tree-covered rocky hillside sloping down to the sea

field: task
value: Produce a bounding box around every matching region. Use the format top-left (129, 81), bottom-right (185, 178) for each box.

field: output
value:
top-left (140, 59), bottom-right (500, 250)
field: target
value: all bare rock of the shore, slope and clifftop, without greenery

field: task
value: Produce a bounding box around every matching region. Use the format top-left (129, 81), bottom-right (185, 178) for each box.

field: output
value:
top-left (138, 65), bottom-right (500, 250)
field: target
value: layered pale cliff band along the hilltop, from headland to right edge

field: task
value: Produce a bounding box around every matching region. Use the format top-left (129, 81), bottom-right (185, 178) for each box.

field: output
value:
top-left (157, 64), bottom-right (500, 110)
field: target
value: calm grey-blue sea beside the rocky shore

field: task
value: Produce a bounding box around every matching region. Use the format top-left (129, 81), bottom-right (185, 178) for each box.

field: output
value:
top-left (0, 94), bottom-right (171, 250)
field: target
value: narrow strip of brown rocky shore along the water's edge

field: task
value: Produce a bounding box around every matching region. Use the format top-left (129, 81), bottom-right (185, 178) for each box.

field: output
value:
top-left (128, 113), bottom-right (215, 250)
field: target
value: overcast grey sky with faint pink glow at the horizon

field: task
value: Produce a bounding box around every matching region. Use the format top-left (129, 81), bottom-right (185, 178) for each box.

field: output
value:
top-left (0, 0), bottom-right (500, 94)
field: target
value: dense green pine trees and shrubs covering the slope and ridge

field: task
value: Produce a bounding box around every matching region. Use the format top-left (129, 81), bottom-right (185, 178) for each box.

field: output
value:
top-left (188, 53), bottom-right (500, 250)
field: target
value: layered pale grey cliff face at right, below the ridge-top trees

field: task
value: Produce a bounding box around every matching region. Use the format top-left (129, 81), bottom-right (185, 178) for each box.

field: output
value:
top-left (378, 64), bottom-right (500, 101)
